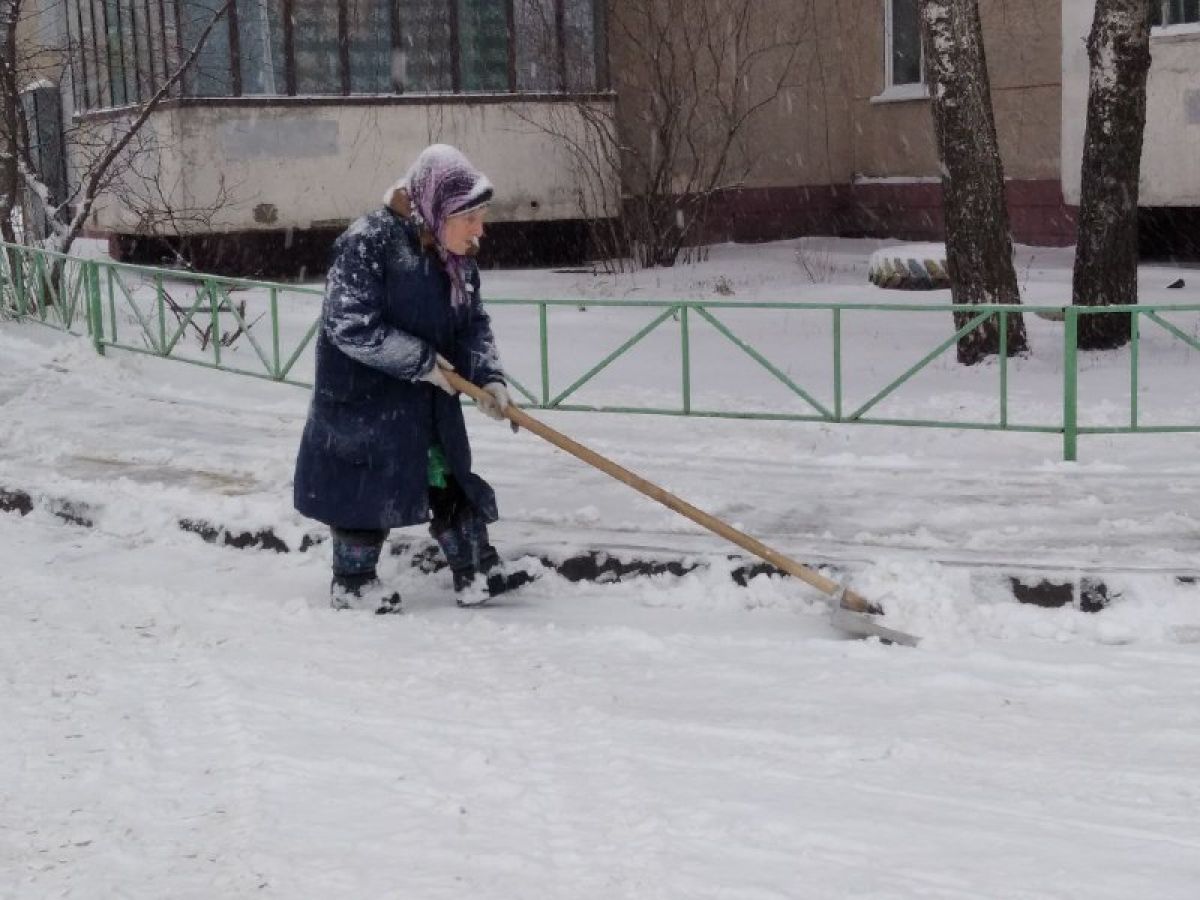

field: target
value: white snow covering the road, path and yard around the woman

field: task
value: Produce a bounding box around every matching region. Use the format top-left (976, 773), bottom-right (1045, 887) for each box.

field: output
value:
top-left (0, 240), bottom-right (1200, 900)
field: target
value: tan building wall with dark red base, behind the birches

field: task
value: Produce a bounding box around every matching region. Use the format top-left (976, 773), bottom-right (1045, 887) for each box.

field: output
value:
top-left (610, 0), bottom-right (1074, 245)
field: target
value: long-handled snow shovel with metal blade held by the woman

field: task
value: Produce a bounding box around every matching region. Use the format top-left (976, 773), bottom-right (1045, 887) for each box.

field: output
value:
top-left (442, 370), bottom-right (918, 647)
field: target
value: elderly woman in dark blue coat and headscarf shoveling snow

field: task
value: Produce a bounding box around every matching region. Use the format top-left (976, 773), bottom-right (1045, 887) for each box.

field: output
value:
top-left (294, 144), bottom-right (520, 612)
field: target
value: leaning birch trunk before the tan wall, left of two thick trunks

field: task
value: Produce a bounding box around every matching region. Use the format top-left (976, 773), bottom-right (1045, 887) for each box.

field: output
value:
top-left (920, 0), bottom-right (1028, 366)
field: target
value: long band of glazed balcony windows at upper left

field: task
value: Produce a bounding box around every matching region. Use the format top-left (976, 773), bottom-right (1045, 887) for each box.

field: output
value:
top-left (67, 0), bottom-right (600, 109)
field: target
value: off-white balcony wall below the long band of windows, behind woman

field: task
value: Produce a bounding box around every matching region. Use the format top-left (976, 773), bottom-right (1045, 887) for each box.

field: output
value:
top-left (87, 100), bottom-right (618, 234)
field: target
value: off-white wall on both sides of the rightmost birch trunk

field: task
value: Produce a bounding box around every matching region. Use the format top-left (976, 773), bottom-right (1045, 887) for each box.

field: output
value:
top-left (1061, 0), bottom-right (1200, 206)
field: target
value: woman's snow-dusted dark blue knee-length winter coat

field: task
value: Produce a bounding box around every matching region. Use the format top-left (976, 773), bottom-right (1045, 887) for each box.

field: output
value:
top-left (295, 209), bottom-right (503, 529)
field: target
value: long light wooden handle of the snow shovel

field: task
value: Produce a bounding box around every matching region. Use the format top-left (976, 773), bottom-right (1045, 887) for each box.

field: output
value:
top-left (443, 370), bottom-right (876, 612)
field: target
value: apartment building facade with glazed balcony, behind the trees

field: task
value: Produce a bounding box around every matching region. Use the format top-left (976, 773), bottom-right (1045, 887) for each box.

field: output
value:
top-left (25, 0), bottom-right (1200, 270)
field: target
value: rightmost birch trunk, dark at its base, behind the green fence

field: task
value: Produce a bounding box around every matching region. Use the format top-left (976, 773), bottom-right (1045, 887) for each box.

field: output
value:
top-left (1070, 0), bottom-right (1150, 350)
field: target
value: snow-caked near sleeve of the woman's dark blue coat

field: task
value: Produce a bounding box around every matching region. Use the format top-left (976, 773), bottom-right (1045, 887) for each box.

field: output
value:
top-left (322, 220), bottom-right (434, 380)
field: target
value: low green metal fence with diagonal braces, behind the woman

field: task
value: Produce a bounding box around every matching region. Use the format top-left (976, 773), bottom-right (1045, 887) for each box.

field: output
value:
top-left (0, 244), bottom-right (1200, 461)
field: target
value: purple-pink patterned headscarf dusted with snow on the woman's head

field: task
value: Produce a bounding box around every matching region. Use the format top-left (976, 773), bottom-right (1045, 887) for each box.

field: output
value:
top-left (396, 144), bottom-right (493, 306)
